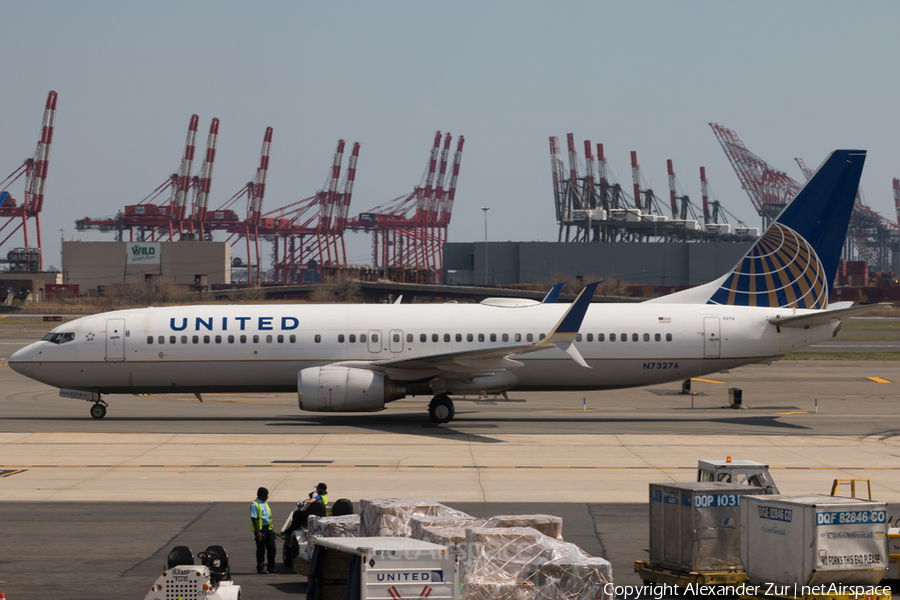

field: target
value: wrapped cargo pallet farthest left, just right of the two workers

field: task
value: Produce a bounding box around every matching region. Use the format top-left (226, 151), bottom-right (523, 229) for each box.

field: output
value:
top-left (359, 498), bottom-right (469, 537)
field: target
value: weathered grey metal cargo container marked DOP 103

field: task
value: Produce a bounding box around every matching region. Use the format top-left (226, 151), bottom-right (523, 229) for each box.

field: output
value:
top-left (650, 482), bottom-right (765, 572)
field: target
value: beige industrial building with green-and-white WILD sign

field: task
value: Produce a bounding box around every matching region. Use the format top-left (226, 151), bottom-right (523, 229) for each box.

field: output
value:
top-left (63, 242), bottom-right (231, 293)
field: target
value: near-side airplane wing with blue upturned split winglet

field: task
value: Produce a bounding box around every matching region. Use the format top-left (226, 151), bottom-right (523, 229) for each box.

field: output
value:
top-left (335, 283), bottom-right (598, 379)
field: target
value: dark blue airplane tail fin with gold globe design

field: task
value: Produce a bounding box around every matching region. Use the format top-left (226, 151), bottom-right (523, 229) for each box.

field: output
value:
top-left (659, 150), bottom-right (866, 309)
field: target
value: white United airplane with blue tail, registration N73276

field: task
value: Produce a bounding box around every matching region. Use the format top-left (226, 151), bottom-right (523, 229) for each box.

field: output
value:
top-left (8, 150), bottom-right (873, 423)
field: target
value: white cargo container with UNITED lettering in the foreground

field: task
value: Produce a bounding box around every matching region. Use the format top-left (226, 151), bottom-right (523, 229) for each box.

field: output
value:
top-left (307, 537), bottom-right (460, 600)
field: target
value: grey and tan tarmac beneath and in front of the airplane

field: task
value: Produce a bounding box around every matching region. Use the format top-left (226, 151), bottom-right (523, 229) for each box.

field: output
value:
top-left (0, 323), bottom-right (900, 600)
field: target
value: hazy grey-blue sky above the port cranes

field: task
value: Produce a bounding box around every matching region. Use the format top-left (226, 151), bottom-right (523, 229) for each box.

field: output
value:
top-left (0, 0), bottom-right (900, 267)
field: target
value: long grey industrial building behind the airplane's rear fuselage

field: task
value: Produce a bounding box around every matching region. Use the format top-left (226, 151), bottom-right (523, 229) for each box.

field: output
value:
top-left (444, 242), bottom-right (753, 286)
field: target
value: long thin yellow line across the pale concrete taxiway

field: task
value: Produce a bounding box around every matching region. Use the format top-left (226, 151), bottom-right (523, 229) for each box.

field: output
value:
top-left (0, 464), bottom-right (900, 477)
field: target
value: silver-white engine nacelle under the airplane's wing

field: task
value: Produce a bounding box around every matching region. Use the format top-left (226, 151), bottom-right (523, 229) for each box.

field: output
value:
top-left (297, 366), bottom-right (406, 412)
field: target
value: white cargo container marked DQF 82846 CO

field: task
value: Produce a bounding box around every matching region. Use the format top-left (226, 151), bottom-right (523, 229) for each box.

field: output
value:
top-left (741, 494), bottom-right (888, 586)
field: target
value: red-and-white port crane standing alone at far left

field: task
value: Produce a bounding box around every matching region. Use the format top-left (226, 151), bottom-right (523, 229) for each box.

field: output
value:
top-left (0, 91), bottom-right (57, 271)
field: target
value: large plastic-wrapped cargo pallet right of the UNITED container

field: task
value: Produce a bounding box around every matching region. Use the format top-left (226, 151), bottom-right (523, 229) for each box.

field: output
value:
top-left (463, 527), bottom-right (612, 600)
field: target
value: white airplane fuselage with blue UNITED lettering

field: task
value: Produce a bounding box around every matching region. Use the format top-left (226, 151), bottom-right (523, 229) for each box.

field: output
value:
top-left (9, 303), bottom-right (835, 393)
